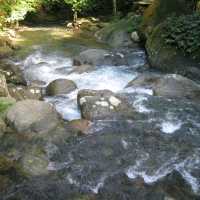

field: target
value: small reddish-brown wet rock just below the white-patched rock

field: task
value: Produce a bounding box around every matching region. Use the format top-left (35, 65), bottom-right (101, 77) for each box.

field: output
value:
top-left (67, 119), bottom-right (91, 135)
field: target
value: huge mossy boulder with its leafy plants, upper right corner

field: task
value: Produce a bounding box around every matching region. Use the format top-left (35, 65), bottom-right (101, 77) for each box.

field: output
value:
top-left (140, 0), bottom-right (200, 80)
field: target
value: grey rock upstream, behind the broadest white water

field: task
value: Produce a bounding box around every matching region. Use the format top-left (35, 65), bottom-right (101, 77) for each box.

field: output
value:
top-left (74, 49), bottom-right (109, 66)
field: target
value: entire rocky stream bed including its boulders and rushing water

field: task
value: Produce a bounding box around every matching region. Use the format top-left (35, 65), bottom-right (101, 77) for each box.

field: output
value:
top-left (0, 23), bottom-right (200, 200)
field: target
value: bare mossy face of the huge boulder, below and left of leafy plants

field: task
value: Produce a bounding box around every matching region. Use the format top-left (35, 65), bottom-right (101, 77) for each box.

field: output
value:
top-left (146, 23), bottom-right (200, 80)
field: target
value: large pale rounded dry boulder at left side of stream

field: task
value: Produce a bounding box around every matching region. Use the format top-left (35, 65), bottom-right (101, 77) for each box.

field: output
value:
top-left (6, 100), bottom-right (59, 134)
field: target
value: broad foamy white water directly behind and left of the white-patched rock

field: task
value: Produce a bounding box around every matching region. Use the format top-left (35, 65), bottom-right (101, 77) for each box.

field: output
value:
top-left (21, 49), bottom-right (138, 120)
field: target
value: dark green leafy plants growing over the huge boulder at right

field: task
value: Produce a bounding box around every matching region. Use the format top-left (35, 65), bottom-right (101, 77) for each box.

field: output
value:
top-left (162, 13), bottom-right (200, 55)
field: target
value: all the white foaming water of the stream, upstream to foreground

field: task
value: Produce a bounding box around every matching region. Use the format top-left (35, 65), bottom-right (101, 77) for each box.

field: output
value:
top-left (10, 41), bottom-right (200, 193)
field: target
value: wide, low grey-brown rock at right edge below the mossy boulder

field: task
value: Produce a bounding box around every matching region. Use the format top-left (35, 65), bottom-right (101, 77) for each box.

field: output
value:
top-left (127, 74), bottom-right (200, 101)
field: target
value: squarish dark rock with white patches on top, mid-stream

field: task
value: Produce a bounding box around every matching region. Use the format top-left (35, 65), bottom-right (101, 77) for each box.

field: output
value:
top-left (78, 90), bottom-right (134, 121)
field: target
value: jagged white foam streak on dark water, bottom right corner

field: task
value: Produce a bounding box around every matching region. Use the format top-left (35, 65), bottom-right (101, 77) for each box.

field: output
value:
top-left (126, 149), bottom-right (200, 193)
